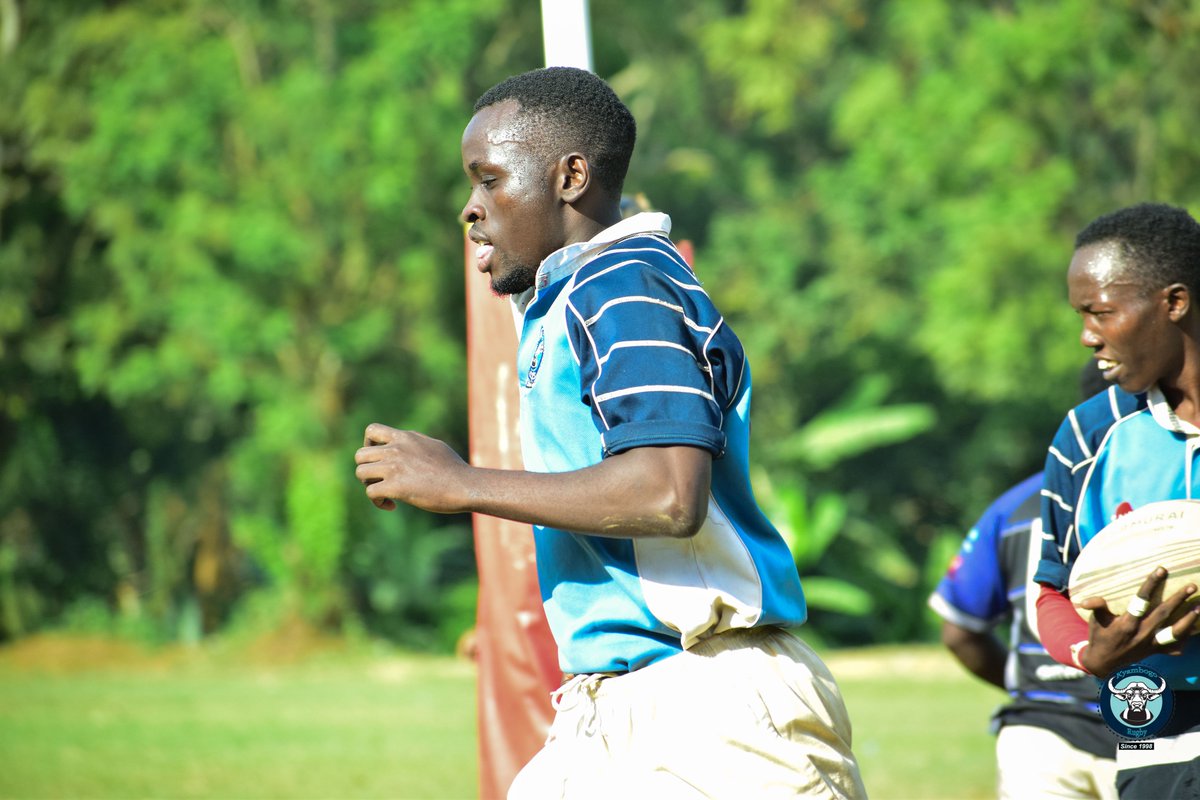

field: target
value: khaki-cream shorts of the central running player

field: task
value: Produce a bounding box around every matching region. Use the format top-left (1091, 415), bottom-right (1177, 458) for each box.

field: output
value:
top-left (509, 627), bottom-right (866, 800)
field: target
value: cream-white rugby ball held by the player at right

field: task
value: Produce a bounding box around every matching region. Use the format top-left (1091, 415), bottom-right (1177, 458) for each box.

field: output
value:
top-left (1067, 500), bottom-right (1200, 622)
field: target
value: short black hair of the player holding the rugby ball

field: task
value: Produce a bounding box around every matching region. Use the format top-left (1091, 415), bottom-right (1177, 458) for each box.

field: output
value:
top-left (1075, 203), bottom-right (1200, 294)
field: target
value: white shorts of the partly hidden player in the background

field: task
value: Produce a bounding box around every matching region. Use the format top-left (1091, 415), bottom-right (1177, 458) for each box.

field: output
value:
top-left (996, 724), bottom-right (1117, 800)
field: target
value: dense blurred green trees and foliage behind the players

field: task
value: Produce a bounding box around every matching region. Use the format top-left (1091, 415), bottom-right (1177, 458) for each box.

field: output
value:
top-left (0, 0), bottom-right (1200, 646)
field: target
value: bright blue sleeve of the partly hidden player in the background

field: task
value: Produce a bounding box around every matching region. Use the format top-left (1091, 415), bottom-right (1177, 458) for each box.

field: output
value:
top-left (929, 503), bottom-right (1009, 633)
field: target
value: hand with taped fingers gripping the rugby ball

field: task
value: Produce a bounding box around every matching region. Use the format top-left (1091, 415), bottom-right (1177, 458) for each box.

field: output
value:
top-left (1079, 567), bottom-right (1200, 676)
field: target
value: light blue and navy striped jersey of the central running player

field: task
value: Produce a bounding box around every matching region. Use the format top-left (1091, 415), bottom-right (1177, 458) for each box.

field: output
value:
top-left (515, 213), bottom-right (806, 674)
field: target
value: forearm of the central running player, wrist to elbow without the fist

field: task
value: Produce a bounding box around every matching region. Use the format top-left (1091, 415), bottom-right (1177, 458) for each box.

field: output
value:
top-left (463, 447), bottom-right (712, 539)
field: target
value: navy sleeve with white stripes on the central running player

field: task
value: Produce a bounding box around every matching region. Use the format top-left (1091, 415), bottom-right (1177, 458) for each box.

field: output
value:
top-left (568, 237), bottom-right (745, 457)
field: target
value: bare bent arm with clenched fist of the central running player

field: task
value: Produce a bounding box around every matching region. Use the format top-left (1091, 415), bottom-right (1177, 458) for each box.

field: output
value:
top-left (355, 423), bottom-right (712, 539)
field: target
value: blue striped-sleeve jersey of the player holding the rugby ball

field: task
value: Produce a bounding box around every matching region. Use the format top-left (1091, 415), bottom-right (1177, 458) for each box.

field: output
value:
top-left (1034, 386), bottom-right (1200, 690)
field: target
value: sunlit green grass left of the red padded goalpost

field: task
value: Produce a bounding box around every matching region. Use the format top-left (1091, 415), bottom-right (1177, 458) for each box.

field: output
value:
top-left (0, 638), bottom-right (478, 799)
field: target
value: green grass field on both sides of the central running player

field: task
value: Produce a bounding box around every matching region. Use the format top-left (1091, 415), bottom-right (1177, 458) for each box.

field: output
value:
top-left (0, 637), bottom-right (1002, 800)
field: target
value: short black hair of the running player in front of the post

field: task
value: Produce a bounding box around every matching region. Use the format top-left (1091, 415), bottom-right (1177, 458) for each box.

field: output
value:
top-left (475, 67), bottom-right (637, 198)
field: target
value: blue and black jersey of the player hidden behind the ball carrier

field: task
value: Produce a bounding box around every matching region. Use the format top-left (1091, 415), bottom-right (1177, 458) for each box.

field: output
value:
top-left (929, 473), bottom-right (1116, 758)
